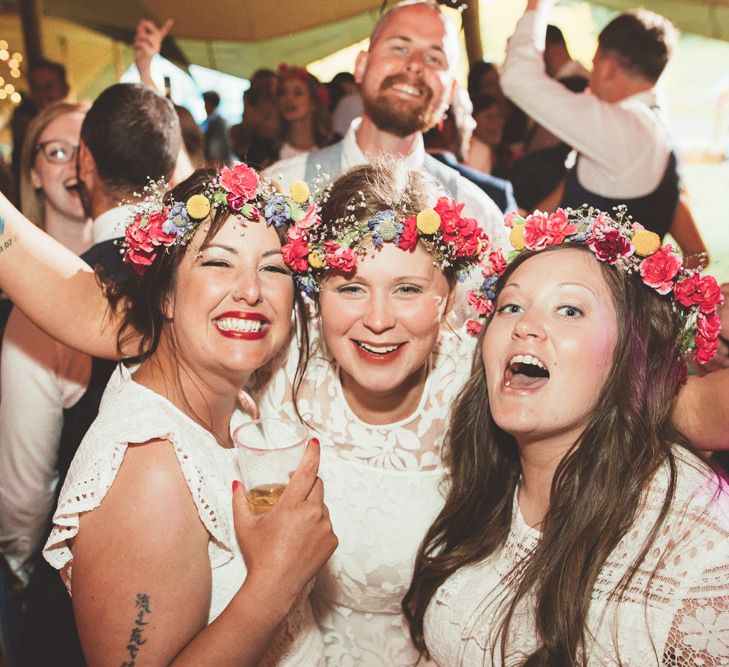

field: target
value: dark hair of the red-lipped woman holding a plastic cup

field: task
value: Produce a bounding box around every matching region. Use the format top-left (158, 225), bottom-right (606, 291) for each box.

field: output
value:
top-left (102, 168), bottom-right (309, 426)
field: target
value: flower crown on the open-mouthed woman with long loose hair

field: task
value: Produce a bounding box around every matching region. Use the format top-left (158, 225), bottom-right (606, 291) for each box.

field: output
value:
top-left (466, 206), bottom-right (724, 364)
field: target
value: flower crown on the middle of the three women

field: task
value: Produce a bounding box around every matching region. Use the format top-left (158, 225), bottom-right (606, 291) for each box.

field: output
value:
top-left (281, 193), bottom-right (490, 296)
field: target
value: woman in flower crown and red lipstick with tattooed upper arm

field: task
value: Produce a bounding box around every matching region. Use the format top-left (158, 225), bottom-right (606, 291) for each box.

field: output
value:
top-left (34, 165), bottom-right (336, 666)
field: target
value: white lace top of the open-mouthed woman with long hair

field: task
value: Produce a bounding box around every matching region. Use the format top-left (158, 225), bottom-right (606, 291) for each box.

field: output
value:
top-left (425, 454), bottom-right (729, 667)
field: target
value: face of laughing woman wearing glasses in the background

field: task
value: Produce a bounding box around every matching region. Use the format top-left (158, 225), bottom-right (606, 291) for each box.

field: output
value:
top-left (30, 112), bottom-right (86, 222)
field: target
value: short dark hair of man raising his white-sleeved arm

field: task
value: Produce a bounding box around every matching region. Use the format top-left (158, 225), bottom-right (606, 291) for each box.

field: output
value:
top-left (598, 9), bottom-right (676, 83)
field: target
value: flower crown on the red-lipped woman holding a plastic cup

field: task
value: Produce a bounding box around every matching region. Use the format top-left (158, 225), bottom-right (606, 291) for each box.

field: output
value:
top-left (121, 163), bottom-right (315, 275)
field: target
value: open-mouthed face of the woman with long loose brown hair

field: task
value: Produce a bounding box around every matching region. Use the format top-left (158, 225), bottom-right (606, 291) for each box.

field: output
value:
top-left (482, 249), bottom-right (618, 446)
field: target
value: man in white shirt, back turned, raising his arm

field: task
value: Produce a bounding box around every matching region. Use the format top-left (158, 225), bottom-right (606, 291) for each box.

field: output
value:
top-left (501, 0), bottom-right (705, 254)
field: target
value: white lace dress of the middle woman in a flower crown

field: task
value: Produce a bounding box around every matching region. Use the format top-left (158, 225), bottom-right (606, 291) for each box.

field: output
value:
top-left (245, 322), bottom-right (474, 667)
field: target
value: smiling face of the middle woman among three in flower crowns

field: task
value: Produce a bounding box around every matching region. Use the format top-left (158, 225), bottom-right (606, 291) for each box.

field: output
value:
top-left (319, 243), bottom-right (450, 423)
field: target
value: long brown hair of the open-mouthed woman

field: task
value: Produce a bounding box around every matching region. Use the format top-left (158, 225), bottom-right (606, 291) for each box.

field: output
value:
top-left (403, 246), bottom-right (708, 667)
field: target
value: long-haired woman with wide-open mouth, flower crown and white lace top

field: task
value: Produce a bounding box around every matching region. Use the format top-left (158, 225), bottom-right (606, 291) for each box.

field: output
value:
top-left (404, 210), bottom-right (729, 667)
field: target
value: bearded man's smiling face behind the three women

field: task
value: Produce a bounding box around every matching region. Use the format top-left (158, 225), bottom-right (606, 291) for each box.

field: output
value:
top-left (354, 4), bottom-right (458, 137)
